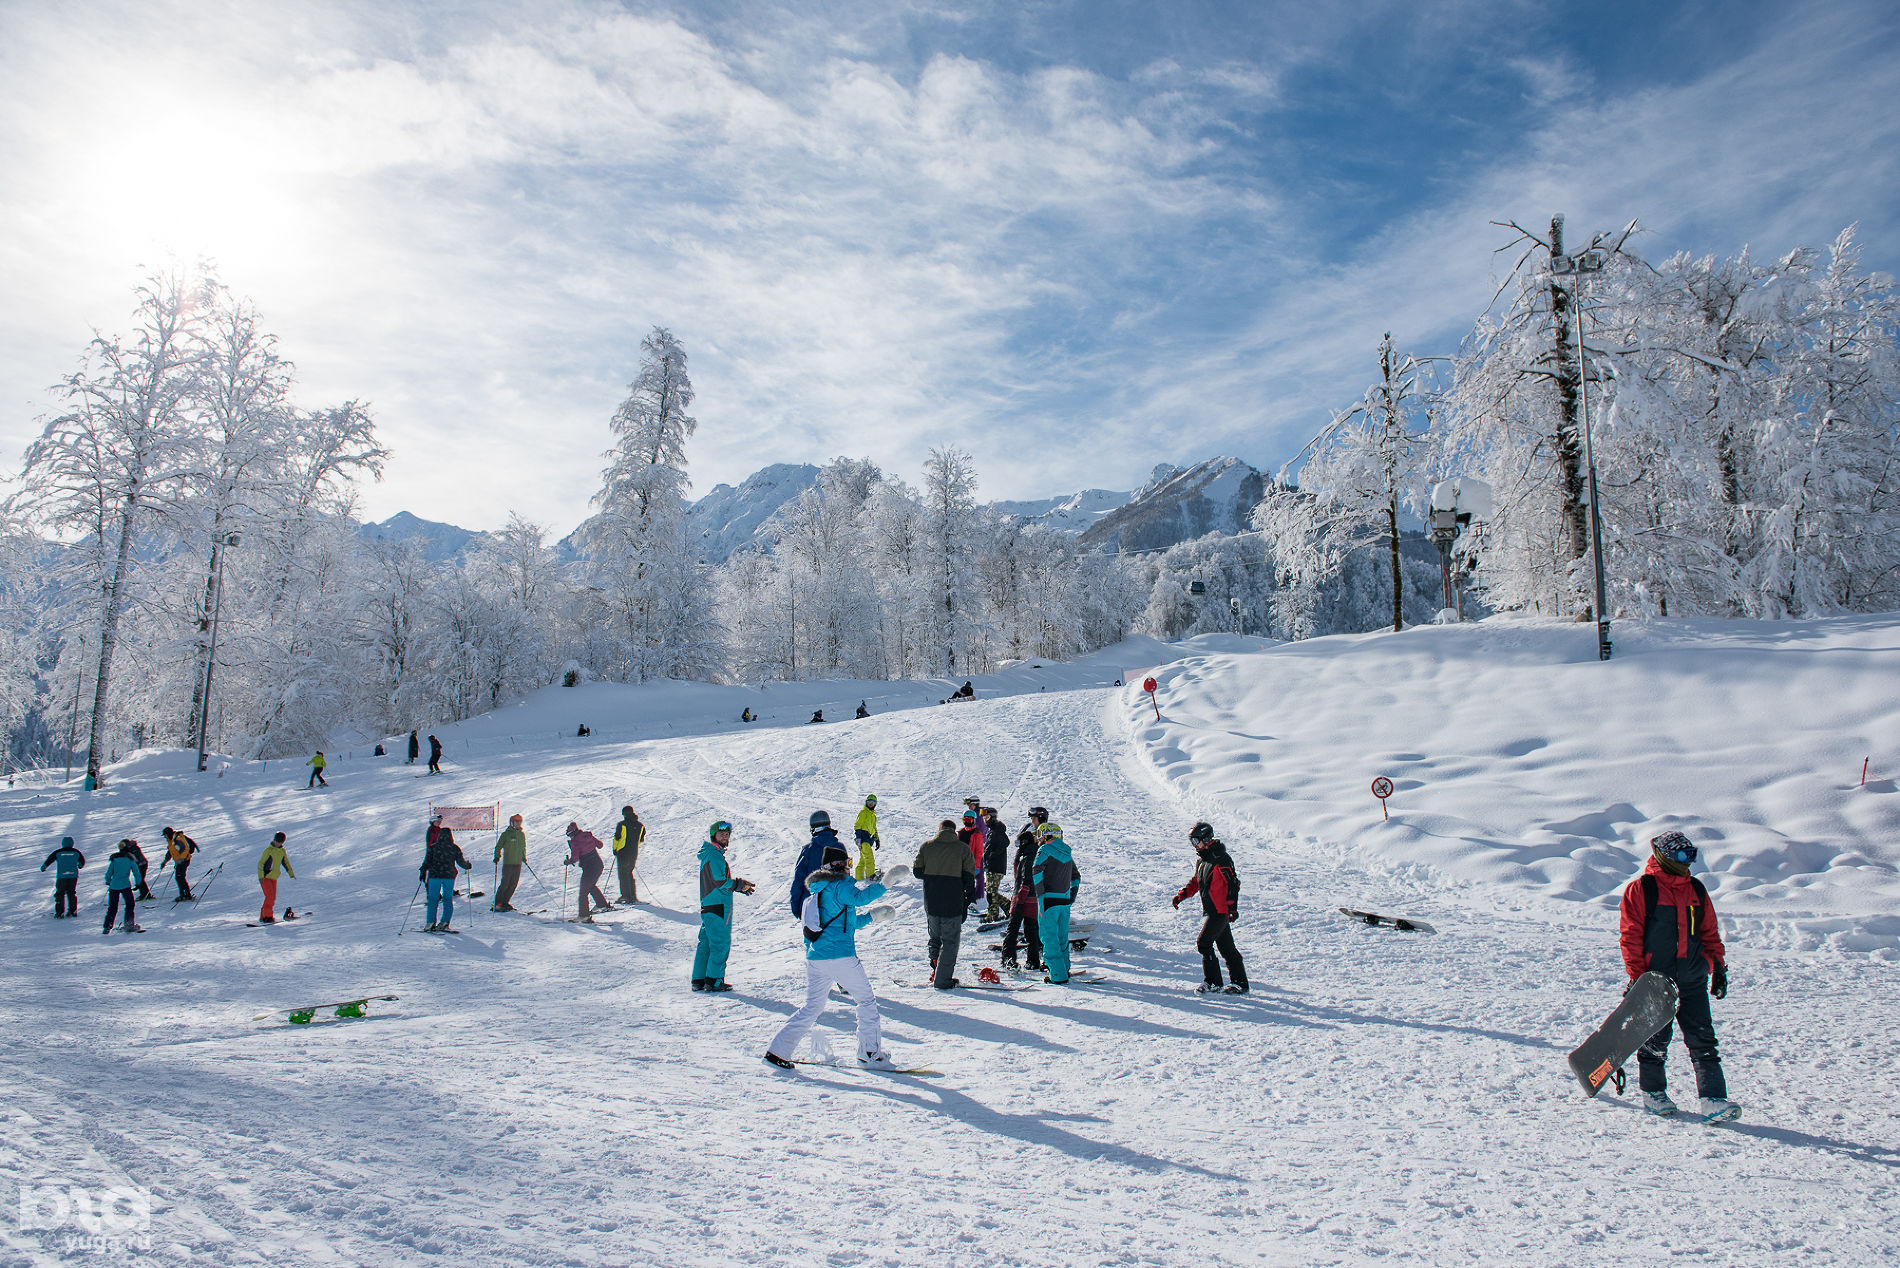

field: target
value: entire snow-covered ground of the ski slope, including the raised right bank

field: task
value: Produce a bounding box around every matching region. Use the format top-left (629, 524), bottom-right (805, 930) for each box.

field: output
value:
top-left (0, 620), bottom-right (1900, 1266)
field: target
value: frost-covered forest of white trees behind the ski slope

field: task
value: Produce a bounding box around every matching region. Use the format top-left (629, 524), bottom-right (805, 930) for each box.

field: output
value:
top-left (0, 219), bottom-right (1900, 772)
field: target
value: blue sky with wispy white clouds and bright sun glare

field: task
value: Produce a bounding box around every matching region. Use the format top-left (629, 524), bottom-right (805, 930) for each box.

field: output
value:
top-left (0, 0), bottom-right (1900, 532)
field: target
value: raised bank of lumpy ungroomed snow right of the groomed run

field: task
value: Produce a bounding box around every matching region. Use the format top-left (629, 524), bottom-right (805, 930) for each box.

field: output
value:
top-left (1127, 616), bottom-right (1900, 958)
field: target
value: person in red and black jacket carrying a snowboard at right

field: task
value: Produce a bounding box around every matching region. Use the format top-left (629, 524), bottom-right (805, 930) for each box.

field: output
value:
top-left (1621, 833), bottom-right (1742, 1122)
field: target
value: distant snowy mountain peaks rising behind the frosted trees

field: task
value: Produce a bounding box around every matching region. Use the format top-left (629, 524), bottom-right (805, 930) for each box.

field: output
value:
top-left (363, 458), bottom-right (1265, 563)
